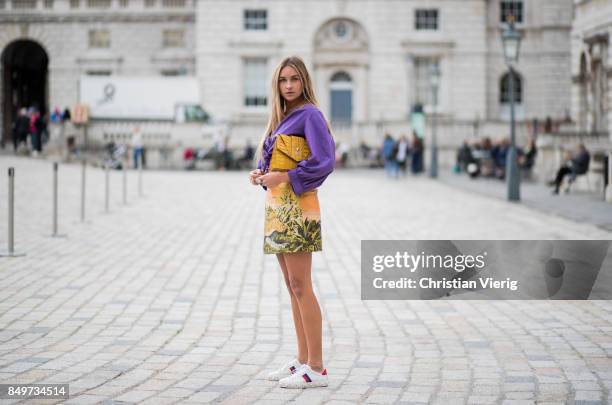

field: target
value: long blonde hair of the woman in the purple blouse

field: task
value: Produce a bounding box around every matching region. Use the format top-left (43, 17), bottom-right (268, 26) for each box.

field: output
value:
top-left (255, 56), bottom-right (331, 164)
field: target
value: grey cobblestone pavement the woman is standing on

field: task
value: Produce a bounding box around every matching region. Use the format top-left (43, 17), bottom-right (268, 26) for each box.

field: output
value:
top-left (0, 157), bottom-right (612, 404)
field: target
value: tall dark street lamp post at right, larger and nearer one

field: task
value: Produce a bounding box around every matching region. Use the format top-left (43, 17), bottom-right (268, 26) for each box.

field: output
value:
top-left (502, 17), bottom-right (521, 201)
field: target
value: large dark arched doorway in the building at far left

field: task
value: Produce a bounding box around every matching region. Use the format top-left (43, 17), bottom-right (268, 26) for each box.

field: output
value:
top-left (2, 39), bottom-right (49, 145)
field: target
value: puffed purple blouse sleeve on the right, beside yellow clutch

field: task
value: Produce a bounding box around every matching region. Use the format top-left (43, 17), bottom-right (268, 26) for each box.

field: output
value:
top-left (288, 110), bottom-right (336, 195)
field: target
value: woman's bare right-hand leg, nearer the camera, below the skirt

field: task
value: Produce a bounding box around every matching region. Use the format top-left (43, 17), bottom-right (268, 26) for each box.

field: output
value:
top-left (284, 252), bottom-right (323, 371)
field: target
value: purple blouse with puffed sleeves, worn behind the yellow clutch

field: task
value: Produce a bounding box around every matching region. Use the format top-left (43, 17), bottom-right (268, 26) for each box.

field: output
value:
top-left (257, 104), bottom-right (336, 195)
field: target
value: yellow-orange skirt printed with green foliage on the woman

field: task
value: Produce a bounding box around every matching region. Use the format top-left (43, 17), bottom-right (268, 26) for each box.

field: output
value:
top-left (264, 182), bottom-right (322, 254)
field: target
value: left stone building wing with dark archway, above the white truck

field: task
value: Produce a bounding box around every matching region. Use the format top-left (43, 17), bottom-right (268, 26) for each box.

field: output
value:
top-left (0, 0), bottom-right (195, 143)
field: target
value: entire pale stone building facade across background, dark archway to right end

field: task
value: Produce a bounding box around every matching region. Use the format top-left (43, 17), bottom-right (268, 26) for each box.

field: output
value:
top-left (0, 0), bottom-right (573, 152)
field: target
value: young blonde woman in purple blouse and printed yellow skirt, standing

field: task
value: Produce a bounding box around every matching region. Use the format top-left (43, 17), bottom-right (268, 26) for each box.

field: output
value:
top-left (249, 56), bottom-right (335, 388)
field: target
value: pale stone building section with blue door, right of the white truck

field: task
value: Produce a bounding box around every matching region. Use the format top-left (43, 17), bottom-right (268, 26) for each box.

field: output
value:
top-left (196, 0), bottom-right (573, 145)
